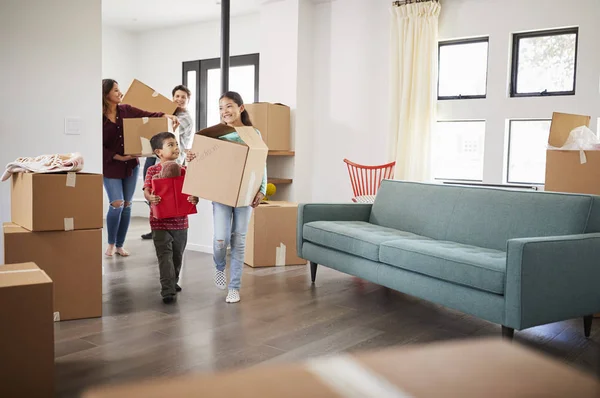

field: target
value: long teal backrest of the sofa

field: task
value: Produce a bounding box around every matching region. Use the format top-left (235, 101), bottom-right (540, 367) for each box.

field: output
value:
top-left (369, 180), bottom-right (600, 251)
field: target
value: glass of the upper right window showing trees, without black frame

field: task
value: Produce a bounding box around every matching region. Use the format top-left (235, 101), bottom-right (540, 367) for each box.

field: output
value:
top-left (517, 33), bottom-right (577, 93)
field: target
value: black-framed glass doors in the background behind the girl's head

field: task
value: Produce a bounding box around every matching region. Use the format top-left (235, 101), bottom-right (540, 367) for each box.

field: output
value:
top-left (183, 54), bottom-right (259, 130)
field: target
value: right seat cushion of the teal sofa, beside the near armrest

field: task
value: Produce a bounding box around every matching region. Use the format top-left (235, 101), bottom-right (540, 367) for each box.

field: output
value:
top-left (379, 240), bottom-right (506, 294)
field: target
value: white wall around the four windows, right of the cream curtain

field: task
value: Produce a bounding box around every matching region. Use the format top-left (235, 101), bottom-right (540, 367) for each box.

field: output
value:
top-left (438, 0), bottom-right (600, 184)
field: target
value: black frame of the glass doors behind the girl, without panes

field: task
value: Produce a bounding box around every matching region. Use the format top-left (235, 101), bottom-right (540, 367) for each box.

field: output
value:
top-left (182, 53), bottom-right (260, 130)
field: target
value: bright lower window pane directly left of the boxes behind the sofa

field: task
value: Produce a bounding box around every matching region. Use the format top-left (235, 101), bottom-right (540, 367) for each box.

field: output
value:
top-left (508, 120), bottom-right (550, 185)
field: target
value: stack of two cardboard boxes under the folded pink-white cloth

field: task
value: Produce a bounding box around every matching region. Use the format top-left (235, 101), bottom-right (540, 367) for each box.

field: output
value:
top-left (3, 173), bottom-right (103, 321)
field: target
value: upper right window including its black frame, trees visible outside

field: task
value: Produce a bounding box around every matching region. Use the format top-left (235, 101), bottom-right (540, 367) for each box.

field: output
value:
top-left (511, 28), bottom-right (579, 97)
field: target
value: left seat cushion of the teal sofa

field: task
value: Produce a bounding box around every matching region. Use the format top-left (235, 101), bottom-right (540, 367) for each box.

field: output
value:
top-left (302, 221), bottom-right (429, 261)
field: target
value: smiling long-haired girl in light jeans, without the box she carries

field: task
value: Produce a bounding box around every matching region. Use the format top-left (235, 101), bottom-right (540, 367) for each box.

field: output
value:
top-left (187, 91), bottom-right (267, 303)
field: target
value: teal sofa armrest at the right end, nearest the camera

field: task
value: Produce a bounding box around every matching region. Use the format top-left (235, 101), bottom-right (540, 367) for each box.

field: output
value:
top-left (504, 233), bottom-right (600, 329)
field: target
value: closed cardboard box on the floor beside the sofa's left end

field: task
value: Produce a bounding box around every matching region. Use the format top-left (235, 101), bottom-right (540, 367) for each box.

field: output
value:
top-left (245, 202), bottom-right (306, 267)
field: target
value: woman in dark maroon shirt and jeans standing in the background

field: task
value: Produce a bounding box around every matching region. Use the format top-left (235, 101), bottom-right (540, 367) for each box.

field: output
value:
top-left (102, 79), bottom-right (178, 257)
